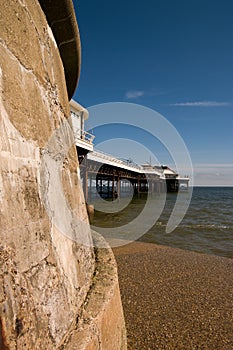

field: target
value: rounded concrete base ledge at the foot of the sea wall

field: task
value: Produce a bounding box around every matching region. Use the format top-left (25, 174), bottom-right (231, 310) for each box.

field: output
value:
top-left (65, 232), bottom-right (127, 350)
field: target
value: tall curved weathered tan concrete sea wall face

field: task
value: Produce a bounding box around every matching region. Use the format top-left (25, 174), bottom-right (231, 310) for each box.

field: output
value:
top-left (0, 0), bottom-right (124, 350)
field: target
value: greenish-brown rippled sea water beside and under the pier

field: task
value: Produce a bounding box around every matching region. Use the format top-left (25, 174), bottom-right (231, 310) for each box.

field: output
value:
top-left (91, 187), bottom-right (233, 258)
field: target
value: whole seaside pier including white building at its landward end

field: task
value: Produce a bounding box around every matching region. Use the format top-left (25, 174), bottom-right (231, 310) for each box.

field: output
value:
top-left (70, 100), bottom-right (189, 202)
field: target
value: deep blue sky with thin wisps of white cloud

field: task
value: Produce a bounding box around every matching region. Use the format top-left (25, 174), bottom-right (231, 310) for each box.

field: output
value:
top-left (73, 0), bottom-right (233, 186)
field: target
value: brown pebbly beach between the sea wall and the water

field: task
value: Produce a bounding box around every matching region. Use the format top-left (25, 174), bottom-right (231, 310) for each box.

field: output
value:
top-left (114, 242), bottom-right (233, 350)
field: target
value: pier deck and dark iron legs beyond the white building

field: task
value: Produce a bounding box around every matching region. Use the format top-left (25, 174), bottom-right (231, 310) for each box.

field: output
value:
top-left (76, 151), bottom-right (189, 202)
